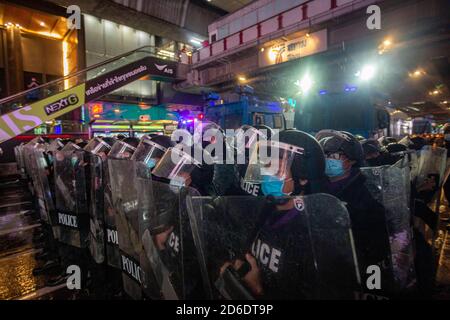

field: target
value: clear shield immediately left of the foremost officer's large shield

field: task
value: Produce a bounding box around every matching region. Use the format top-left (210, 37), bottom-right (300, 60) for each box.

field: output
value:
top-left (137, 179), bottom-right (207, 300)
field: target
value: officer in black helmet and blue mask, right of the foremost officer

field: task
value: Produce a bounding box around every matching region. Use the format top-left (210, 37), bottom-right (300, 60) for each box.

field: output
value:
top-left (317, 130), bottom-right (390, 296)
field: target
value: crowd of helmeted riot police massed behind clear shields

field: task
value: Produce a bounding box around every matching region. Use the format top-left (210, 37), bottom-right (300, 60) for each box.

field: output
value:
top-left (16, 123), bottom-right (445, 300)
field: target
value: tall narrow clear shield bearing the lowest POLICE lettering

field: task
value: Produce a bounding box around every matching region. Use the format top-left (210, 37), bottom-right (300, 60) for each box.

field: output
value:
top-left (109, 159), bottom-right (142, 300)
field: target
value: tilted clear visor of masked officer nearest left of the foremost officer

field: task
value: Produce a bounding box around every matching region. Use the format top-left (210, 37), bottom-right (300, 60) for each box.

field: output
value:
top-left (152, 147), bottom-right (201, 186)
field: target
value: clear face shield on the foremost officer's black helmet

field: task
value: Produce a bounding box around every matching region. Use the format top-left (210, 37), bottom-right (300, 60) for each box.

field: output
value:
top-left (244, 141), bottom-right (304, 183)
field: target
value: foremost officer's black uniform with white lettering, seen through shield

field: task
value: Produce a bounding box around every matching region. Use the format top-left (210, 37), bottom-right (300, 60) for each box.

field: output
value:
top-left (251, 207), bottom-right (318, 300)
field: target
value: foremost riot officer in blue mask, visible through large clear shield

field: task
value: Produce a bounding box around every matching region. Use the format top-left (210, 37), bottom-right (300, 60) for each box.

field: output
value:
top-left (201, 130), bottom-right (356, 299)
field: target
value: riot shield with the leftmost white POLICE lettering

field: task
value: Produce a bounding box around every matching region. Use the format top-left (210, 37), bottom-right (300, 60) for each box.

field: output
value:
top-left (54, 150), bottom-right (89, 248)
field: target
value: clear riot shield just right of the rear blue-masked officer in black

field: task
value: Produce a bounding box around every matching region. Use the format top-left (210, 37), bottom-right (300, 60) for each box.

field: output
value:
top-left (361, 158), bottom-right (416, 297)
